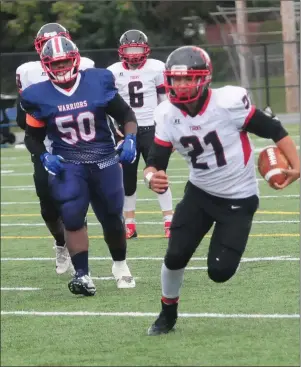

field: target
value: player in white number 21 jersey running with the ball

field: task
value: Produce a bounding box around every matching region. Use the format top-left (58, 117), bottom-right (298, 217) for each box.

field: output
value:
top-left (144, 46), bottom-right (300, 335)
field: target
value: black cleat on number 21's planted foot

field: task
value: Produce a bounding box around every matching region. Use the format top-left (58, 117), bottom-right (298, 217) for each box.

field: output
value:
top-left (147, 301), bottom-right (178, 336)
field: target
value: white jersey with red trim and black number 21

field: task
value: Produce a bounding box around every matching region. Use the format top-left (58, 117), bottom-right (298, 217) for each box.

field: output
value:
top-left (154, 86), bottom-right (258, 198)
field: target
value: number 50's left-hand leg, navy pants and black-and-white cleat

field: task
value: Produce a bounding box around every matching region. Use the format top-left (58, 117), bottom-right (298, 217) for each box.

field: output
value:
top-left (49, 163), bottom-right (96, 296)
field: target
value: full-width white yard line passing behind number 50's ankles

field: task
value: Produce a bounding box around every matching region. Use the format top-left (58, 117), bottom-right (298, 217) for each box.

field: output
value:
top-left (1, 255), bottom-right (300, 262)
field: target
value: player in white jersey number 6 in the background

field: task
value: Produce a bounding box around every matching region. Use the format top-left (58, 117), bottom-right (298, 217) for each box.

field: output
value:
top-left (108, 30), bottom-right (172, 239)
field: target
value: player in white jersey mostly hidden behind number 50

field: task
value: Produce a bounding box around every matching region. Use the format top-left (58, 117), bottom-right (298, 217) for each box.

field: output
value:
top-left (16, 23), bottom-right (94, 274)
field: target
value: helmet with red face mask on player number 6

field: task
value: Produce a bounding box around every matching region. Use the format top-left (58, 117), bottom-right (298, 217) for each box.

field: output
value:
top-left (118, 29), bottom-right (150, 66)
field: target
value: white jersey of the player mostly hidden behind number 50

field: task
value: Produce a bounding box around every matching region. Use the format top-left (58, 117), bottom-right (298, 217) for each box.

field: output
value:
top-left (16, 57), bottom-right (95, 93)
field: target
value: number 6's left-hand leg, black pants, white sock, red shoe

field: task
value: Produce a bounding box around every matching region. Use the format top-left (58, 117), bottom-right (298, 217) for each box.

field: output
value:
top-left (122, 136), bottom-right (140, 239)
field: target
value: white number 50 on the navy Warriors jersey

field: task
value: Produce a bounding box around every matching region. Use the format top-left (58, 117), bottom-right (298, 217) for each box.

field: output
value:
top-left (55, 111), bottom-right (96, 145)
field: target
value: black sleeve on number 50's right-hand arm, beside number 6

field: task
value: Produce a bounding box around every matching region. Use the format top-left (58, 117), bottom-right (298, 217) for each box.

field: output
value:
top-left (106, 93), bottom-right (137, 125)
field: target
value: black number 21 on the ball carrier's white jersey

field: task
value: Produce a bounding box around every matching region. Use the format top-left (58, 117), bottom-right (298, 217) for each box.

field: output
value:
top-left (180, 131), bottom-right (227, 169)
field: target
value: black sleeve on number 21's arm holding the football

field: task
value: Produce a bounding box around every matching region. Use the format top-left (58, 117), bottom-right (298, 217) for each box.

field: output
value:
top-left (244, 109), bottom-right (288, 143)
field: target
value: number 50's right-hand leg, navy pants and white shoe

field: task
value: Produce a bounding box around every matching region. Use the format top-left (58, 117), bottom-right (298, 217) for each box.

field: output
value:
top-left (90, 164), bottom-right (135, 288)
